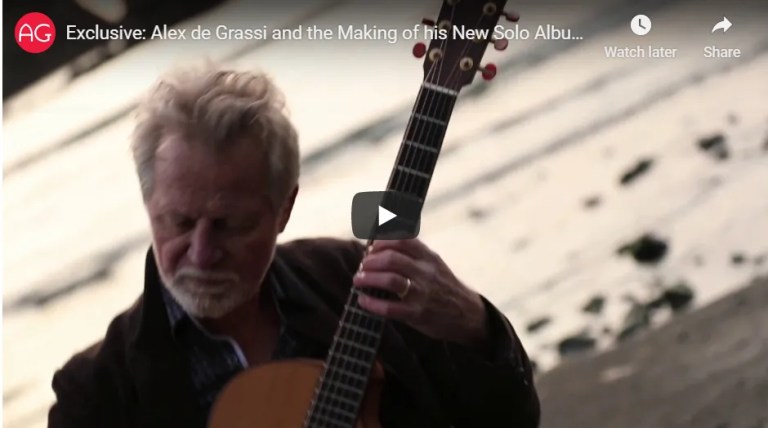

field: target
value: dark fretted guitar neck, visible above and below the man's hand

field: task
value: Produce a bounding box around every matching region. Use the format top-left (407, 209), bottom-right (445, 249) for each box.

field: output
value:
top-left (305, 81), bottom-right (458, 428)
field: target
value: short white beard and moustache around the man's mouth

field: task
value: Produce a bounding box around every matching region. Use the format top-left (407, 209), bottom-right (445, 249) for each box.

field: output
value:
top-left (163, 268), bottom-right (256, 319)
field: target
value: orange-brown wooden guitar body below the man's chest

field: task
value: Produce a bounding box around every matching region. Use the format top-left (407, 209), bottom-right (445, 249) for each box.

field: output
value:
top-left (208, 359), bottom-right (384, 428)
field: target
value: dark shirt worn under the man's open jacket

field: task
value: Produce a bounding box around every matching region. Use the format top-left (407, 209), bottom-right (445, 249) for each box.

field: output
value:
top-left (163, 274), bottom-right (322, 417)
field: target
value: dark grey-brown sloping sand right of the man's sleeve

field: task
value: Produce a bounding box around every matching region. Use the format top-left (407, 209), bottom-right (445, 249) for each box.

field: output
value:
top-left (538, 278), bottom-right (768, 428)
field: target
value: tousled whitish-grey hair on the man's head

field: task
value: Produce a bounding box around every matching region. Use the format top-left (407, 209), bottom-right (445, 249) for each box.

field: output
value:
top-left (131, 64), bottom-right (299, 203)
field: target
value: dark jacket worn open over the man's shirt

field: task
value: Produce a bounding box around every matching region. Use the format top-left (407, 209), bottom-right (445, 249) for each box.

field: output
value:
top-left (48, 239), bottom-right (539, 428)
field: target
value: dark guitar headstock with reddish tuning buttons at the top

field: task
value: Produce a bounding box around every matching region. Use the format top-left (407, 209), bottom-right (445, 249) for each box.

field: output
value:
top-left (413, 0), bottom-right (519, 91)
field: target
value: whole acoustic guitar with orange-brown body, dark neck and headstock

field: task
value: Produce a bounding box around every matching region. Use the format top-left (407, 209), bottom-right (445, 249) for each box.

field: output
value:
top-left (208, 0), bottom-right (518, 428)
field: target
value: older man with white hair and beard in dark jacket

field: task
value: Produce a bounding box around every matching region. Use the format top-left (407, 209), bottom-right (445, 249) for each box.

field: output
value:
top-left (49, 69), bottom-right (539, 428)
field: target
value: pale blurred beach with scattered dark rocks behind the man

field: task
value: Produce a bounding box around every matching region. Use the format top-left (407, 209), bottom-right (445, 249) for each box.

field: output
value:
top-left (2, 0), bottom-right (768, 428)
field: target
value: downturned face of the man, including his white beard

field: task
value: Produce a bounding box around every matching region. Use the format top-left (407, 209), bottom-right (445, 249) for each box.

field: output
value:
top-left (147, 136), bottom-right (295, 318)
